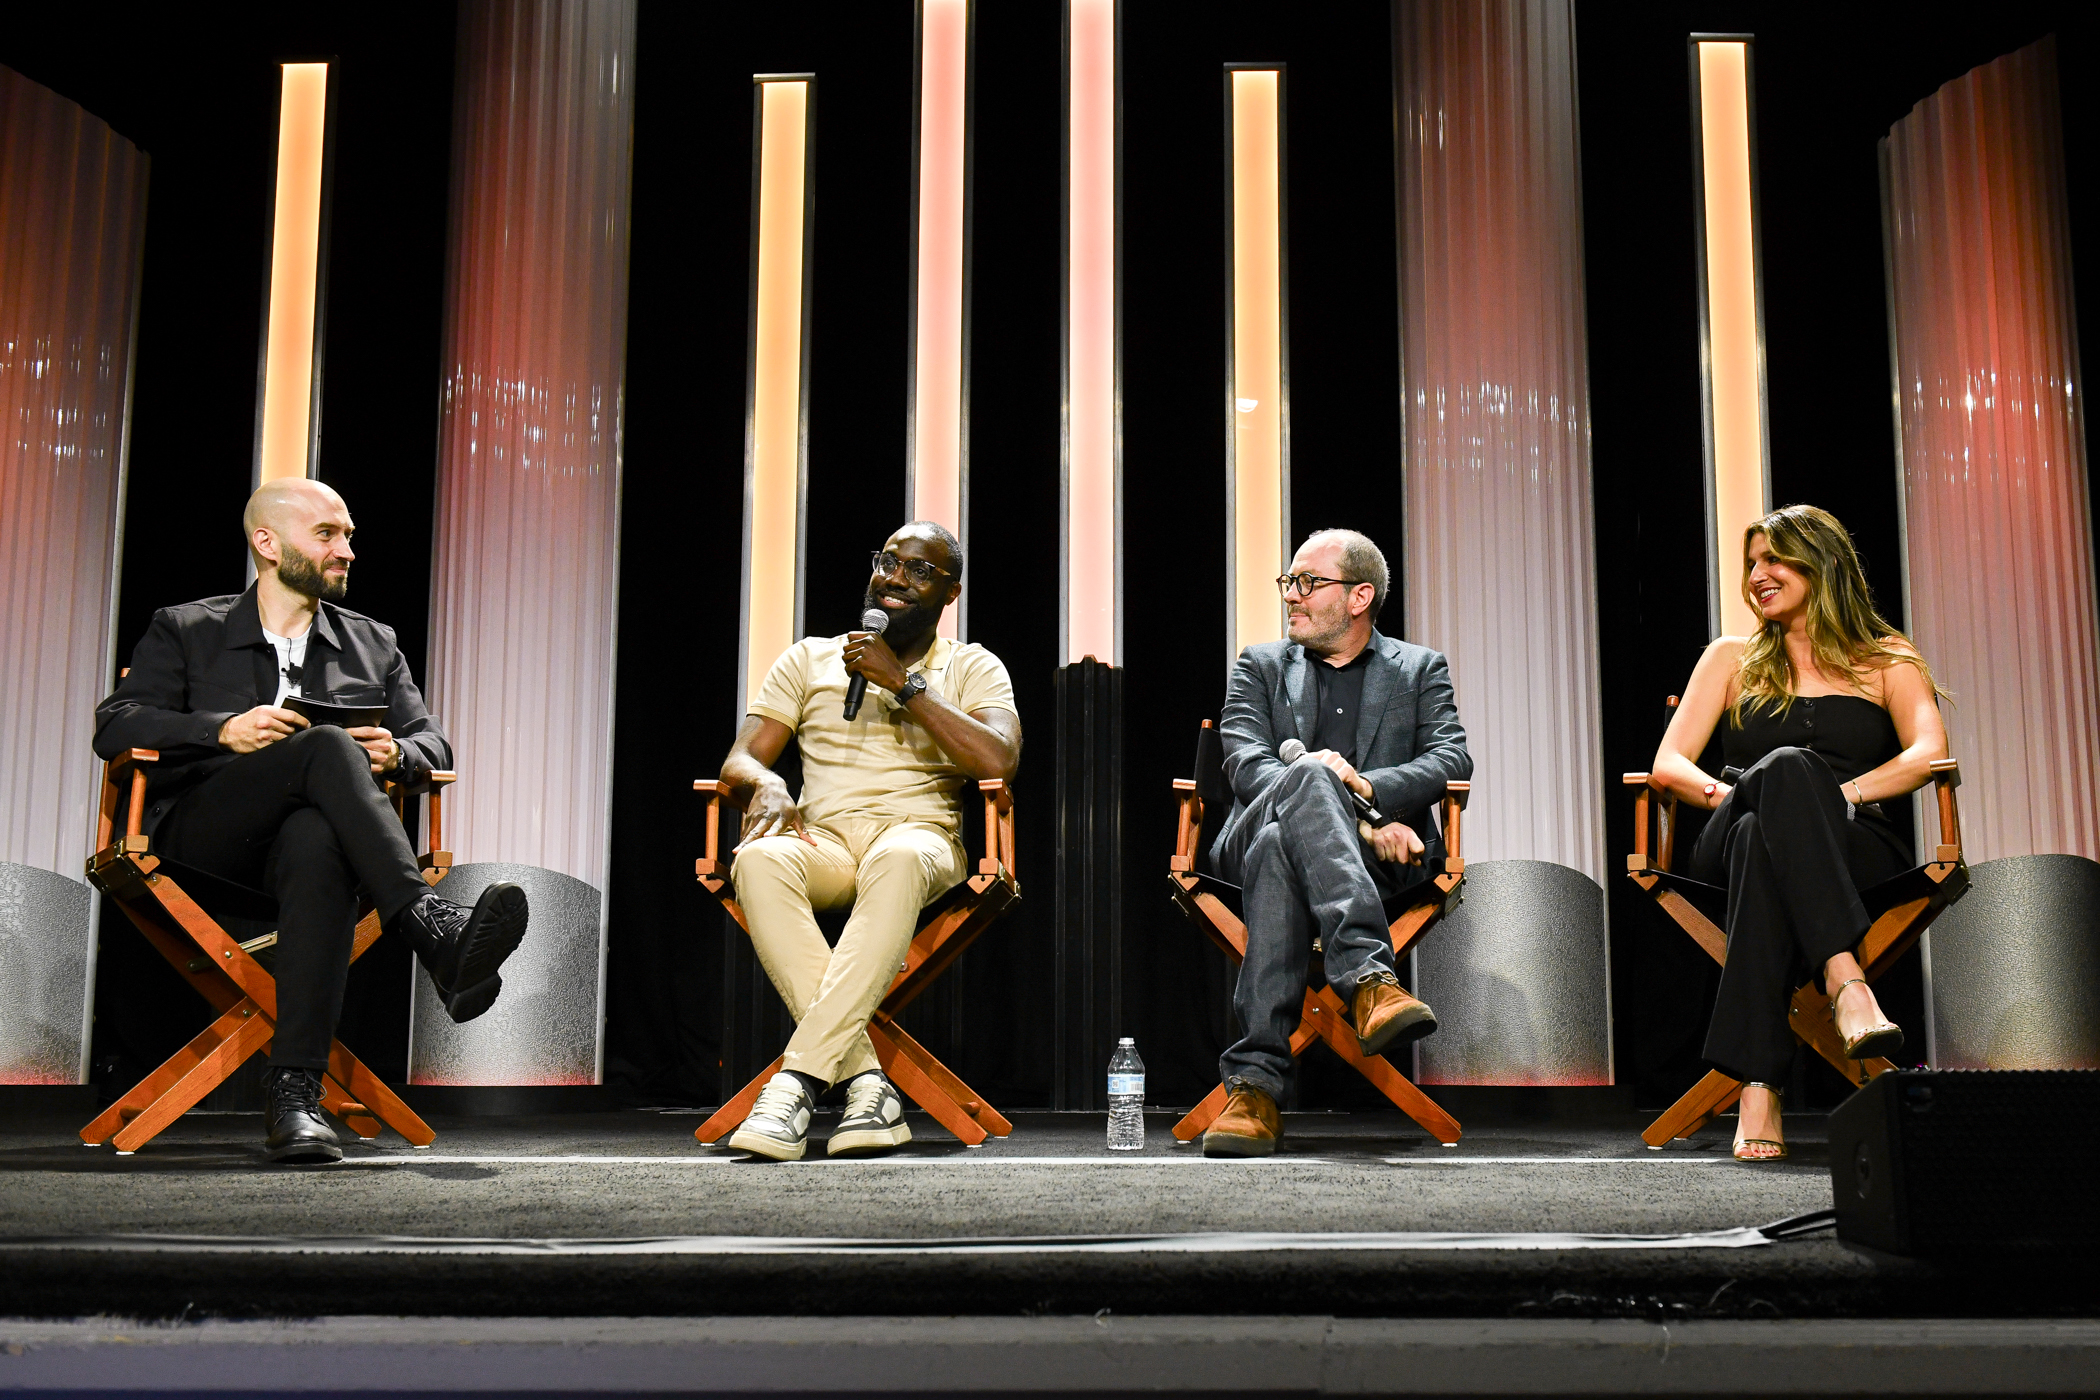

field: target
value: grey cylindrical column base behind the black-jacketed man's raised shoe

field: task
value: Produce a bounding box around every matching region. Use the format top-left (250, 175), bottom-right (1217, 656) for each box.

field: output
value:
top-left (407, 861), bottom-right (605, 1085)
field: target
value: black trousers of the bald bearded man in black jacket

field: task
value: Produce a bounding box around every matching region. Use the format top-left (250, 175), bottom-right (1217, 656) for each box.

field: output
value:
top-left (153, 724), bottom-right (431, 1070)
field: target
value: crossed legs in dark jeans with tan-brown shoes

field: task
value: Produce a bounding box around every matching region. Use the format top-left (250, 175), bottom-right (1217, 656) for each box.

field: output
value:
top-left (1203, 762), bottom-right (1436, 1157)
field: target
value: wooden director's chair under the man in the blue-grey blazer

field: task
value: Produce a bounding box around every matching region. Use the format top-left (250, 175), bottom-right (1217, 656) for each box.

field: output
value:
top-left (1168, 720), bottom-right (1472, 1146)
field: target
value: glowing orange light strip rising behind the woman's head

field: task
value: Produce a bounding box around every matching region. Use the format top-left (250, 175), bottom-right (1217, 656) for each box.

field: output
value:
top-left (1697, 40), bottom-right (1770, 636)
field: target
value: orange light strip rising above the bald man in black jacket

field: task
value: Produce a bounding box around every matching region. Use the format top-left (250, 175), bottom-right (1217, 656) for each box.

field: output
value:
top-left (256, 63), bottom-right (328, 485)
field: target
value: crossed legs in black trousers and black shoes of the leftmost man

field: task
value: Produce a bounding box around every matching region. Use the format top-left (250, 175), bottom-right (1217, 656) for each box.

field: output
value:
top-left (153, 726), bottom-right (527, 1161)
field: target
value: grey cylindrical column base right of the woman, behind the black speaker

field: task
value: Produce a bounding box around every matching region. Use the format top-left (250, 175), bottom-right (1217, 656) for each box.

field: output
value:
top-left (1926, 856), bottom-right (2100, 1070)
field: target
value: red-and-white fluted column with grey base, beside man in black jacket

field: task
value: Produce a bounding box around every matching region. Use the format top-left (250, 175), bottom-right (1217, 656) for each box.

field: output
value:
top-left (410, 0), bottom-right (634, 1085)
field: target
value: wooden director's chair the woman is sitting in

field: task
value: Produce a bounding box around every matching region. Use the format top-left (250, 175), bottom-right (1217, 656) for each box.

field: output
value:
top-left (1619, 695), bottom-right (1970, 1148)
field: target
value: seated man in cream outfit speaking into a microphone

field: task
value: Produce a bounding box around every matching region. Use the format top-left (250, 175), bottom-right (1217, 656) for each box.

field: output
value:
top-left (722, 521), bottom-right (1021, 1161)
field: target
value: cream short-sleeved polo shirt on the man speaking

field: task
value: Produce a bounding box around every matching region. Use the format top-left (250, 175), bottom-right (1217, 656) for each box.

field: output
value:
top-left (750, 636), bottom-right (1019, 831)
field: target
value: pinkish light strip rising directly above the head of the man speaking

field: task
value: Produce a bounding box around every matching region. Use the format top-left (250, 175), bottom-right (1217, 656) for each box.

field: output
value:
top-left (911, 0), bottom-right (970, 636)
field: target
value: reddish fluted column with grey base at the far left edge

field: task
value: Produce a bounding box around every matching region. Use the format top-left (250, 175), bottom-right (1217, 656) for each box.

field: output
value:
top-left (0, 67), bottom-right (147, 1083)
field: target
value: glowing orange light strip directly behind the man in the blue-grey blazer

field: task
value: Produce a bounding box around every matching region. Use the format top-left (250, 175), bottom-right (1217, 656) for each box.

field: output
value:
top-left (1226, 69), bottom-right (1289, 665)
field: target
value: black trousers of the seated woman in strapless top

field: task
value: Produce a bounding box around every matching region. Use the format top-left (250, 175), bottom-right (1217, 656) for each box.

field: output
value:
top-left (1691, 747), bottom-right (1909, 1085)
